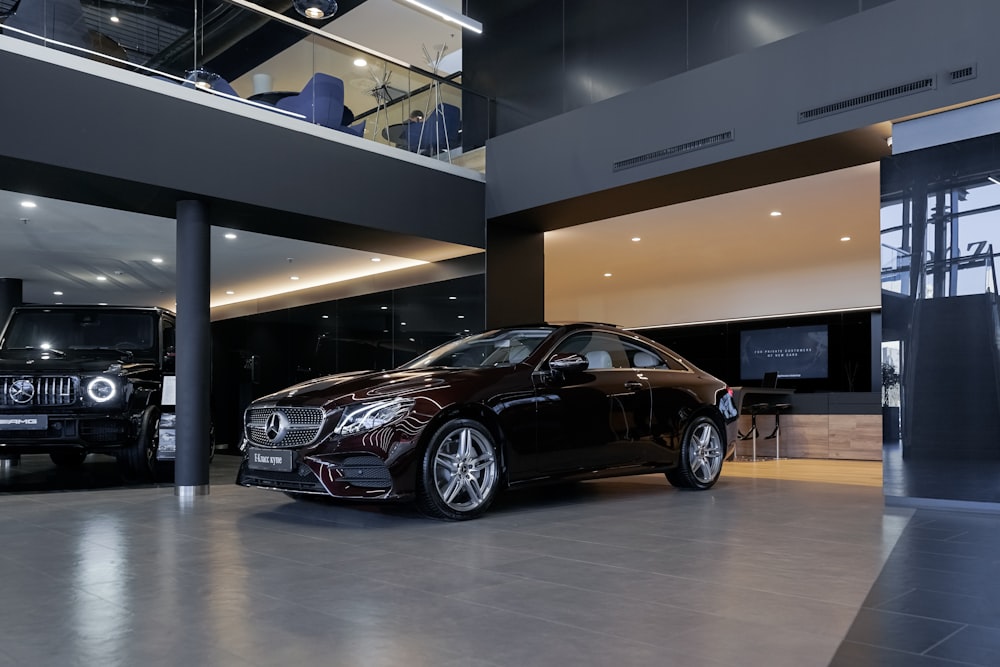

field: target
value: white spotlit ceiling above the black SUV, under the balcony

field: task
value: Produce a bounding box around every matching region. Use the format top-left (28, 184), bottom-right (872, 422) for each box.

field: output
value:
top-left (0, 192), bottom-right (430, 309)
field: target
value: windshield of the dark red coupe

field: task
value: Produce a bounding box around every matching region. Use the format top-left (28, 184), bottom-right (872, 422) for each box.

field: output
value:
top-left (401, 327), bottom-right (555, 368)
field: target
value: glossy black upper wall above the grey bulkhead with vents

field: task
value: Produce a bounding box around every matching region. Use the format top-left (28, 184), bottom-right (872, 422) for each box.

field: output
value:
top-left (462, 0), bottom-right (890, 134)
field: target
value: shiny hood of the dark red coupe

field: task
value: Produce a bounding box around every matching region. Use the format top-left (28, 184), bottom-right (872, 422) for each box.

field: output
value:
top-left (254, 368), bottom-right (494, 406)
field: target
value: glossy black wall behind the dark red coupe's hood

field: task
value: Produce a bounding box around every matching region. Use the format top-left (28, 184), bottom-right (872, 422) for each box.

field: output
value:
top-left (212, 275), bottom-right (486, 446)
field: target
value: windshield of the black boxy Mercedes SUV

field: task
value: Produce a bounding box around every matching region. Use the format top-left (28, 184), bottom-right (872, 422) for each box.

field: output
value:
top-left (3, 310), bottom-right (156, 351)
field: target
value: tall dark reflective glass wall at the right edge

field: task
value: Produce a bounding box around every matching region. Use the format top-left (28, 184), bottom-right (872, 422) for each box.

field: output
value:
top-left (881, 135), bottom-right (1000, 502)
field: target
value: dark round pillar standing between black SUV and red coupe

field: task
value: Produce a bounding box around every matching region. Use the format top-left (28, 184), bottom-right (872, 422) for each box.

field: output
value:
top-left (174, 200), bottom-right (212, 497)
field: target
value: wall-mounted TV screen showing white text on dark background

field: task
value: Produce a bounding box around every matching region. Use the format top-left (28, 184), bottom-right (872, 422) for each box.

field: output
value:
top-left (740, 324), bottom-right (830, 380)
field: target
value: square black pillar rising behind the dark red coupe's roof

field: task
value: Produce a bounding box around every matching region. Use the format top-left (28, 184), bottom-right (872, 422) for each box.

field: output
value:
top-left (486, 223), bottom-right (545, 328)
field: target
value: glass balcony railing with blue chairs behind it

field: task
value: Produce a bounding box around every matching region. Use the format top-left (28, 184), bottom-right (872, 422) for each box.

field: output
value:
top-left (0, 0), bottom-right (490, 167)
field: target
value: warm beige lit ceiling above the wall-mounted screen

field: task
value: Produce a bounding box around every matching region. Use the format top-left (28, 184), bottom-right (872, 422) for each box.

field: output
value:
top-left (545, 162), bottom-right (879, 300)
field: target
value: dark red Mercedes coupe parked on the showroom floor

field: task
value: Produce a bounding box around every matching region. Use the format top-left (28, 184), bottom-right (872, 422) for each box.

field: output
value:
top-left (237, 323), bottom-right (737, 519)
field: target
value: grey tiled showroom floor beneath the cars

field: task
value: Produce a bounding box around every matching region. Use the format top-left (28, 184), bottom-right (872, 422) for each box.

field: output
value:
top-left (0, 456), bottom-right (998, 667)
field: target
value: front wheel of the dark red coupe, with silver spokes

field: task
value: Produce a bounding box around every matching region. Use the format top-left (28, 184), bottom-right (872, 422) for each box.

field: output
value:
top-left (417, 419), bottom-right (500, 521)
